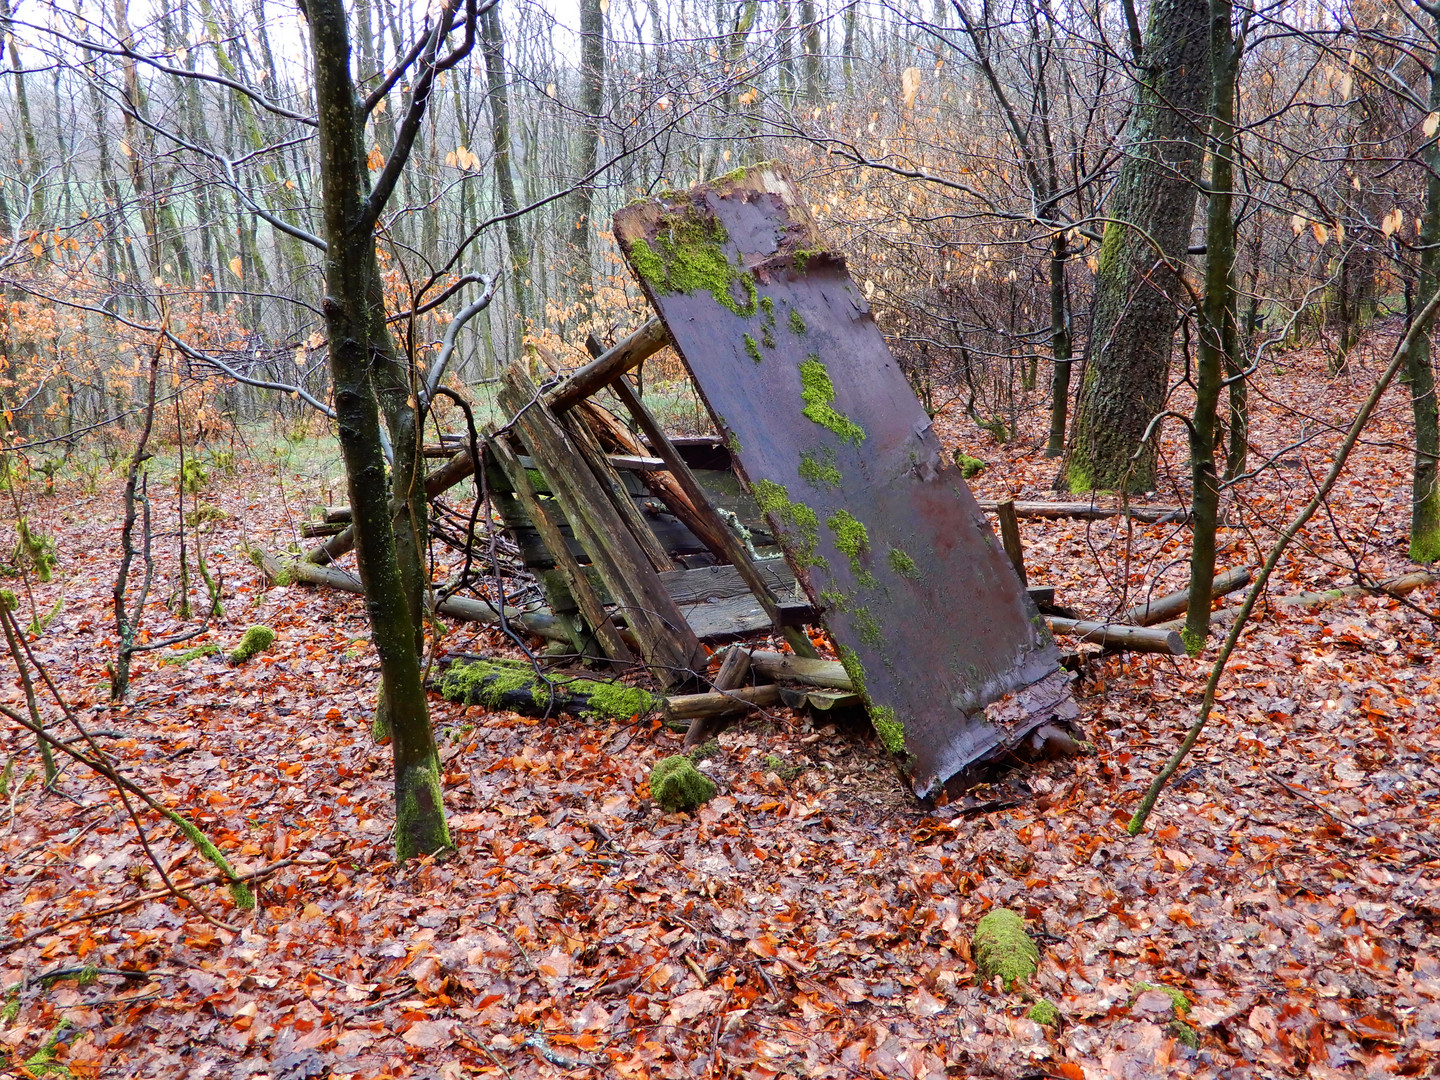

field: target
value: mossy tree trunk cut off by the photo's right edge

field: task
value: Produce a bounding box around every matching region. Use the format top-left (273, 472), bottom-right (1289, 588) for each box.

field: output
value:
top-left (1405, 13), bottom-right (1440, 563)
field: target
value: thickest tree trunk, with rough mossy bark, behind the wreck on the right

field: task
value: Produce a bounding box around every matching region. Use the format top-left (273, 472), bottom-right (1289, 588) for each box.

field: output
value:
top-left (1063, 0), bottom-right (1208, 491)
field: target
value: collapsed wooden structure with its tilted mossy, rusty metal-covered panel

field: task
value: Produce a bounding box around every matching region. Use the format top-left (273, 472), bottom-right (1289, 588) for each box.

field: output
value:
top-left (274, 166), bottom-right (1261, 796)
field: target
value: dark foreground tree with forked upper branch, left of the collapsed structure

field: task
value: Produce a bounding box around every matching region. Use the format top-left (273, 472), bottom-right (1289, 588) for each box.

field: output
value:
top-left (307, 0), bottom-right (460, 860)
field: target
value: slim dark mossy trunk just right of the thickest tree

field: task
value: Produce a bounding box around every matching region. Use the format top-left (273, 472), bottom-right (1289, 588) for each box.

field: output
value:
top-left (1184, 0), bottom-right (1243, 655)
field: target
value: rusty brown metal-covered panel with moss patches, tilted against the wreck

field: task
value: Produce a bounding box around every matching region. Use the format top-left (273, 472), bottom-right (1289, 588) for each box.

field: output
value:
top-left (615, 166), bottom-right (1076, 796)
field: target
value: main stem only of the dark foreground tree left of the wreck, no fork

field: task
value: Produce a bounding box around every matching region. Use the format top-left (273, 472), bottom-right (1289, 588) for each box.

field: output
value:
top-left (308, 0), bottom-right (449, 860)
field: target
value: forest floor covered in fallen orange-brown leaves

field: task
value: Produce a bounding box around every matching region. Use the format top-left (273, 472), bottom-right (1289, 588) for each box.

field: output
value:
top-left (0, 324), bottom-right (1440, 1080)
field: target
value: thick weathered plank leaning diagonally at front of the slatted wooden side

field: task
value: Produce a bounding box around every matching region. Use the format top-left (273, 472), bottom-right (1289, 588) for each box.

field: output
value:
top-left (500, 364), bottom-right (706, 685)
